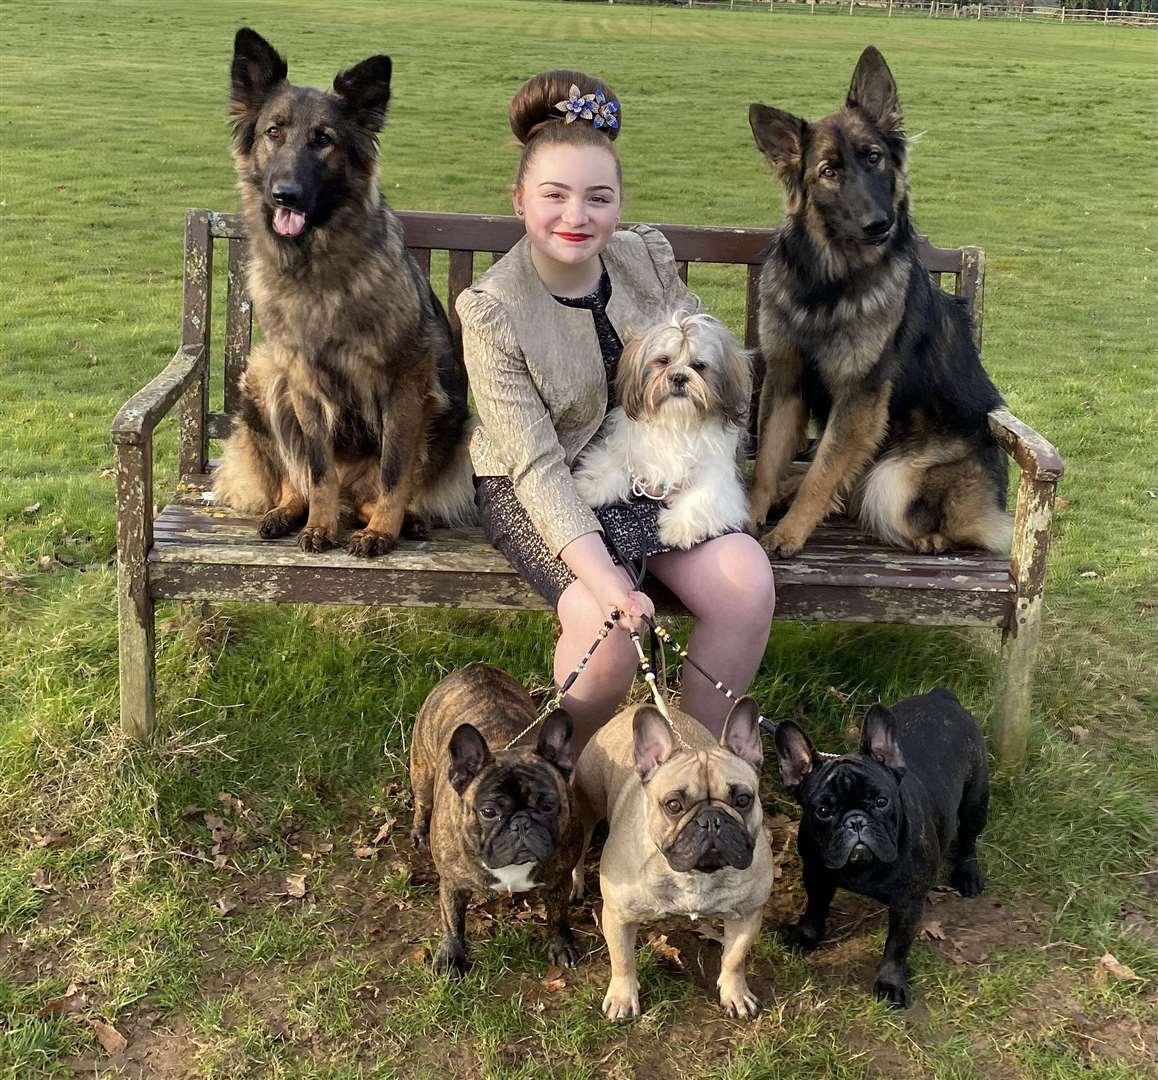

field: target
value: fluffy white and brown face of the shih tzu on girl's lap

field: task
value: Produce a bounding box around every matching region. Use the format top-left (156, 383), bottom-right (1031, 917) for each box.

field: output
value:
top-left (615, 311), bottom-right (752, 426)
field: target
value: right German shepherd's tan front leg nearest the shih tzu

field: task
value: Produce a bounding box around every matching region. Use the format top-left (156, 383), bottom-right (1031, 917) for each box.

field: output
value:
top-left (748, 348), bottom-right (808, 531)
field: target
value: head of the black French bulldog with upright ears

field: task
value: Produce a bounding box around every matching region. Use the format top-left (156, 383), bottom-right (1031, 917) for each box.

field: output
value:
top-left (776, 705), bottom-right (904, 870)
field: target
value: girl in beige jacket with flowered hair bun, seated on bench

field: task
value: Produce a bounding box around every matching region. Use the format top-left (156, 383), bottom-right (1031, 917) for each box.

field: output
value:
top-left (456, 71), bottom-right (776, 752)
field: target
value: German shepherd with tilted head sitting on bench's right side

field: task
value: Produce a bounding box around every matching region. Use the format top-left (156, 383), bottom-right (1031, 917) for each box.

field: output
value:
top-left (748, 46), bottom-right (1012, 556)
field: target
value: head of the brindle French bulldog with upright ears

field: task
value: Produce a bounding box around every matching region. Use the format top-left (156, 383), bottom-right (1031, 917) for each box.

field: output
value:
top-left (449, 710), bottom-right (573, 865)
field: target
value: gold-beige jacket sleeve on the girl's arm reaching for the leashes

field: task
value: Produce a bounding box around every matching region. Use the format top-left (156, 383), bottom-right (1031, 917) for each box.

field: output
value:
top-left (455, 289), bottom-right (602, 556)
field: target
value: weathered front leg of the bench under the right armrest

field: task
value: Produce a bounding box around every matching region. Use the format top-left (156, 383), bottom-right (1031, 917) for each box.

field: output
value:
top-left (994, 475), bottom-right (1057, 770)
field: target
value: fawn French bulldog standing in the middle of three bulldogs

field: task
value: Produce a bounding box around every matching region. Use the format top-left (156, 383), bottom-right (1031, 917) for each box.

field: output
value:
top-left (572, 698), bottom-right (772, 1020)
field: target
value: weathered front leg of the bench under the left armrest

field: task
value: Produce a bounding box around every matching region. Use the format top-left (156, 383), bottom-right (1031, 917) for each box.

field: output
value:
top-left (117, 439), bottom-right (156, 741)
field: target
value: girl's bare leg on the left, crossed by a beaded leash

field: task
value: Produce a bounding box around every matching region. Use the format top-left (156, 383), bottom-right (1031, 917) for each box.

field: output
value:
top-left (555, 581), bottom-right (639, 758)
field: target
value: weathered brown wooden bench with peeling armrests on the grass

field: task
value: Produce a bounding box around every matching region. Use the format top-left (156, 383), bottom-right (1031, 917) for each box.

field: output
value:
top-left (112, 210), bottom-right (1062, 765)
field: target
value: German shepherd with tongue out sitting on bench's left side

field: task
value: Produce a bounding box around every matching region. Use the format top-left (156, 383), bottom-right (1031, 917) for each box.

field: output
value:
top-left (213, 29), bottom-right (474, 556)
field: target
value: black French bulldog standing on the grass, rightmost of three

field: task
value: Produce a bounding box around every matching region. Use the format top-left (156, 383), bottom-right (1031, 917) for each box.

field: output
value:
top-left (776, 690), bottom-right (989, 1008)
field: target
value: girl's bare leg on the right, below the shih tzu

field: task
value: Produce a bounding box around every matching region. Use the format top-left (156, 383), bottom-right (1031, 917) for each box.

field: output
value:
top-left (648, 532), bottom-right (776, 736)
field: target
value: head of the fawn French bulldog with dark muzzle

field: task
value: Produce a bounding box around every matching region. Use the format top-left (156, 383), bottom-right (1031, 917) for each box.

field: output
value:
top-left (635, 698), bottom-right (763, 874)
